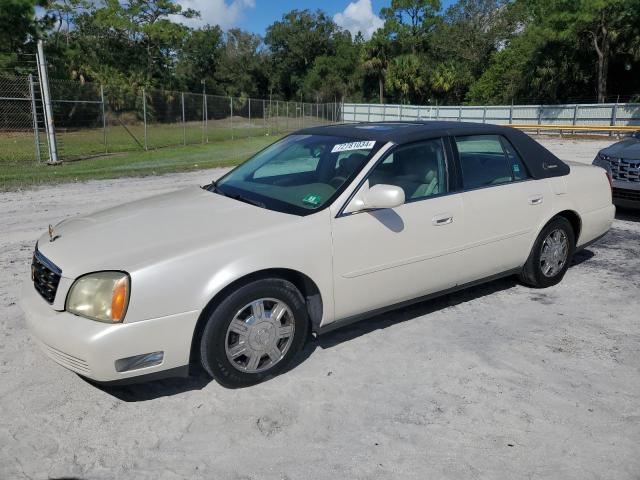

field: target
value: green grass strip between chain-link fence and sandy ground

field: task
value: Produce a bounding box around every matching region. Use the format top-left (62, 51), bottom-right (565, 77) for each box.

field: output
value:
top-left (0, 135), bottom-right (279, 191)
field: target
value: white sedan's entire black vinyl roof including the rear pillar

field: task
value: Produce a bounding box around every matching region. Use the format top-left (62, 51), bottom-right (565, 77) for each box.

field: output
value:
top-left (294, 121), bottom-right (569, 179)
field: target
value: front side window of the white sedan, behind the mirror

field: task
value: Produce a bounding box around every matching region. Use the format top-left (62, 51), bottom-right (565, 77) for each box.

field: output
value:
top-left (369, 139), bottom-right (447, 201)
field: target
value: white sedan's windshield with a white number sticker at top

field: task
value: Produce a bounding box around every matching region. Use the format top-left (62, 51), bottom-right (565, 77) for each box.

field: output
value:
top-left (206, 135), bottom-right (381, 215)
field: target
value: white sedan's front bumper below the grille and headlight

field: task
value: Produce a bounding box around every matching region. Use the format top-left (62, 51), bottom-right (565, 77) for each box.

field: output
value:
top-left (20, 281), bottom-right (199, 383)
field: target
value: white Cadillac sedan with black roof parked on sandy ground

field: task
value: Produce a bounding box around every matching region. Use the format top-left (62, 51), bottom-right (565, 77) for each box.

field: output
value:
top-left (21, 122), bottom-right (615, 387)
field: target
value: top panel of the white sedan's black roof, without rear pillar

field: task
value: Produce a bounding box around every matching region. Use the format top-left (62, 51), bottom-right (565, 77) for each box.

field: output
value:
top-left (294, 121), bottom-right (508, 144)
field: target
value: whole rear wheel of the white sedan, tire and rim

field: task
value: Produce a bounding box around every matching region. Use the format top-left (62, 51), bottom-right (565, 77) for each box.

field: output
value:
top-left (520, 217), bottom-right (575, 288)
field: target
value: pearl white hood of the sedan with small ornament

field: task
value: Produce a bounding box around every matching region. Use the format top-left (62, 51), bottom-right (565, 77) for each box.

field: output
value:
top-left (38, 187), bottom-right (301, 278)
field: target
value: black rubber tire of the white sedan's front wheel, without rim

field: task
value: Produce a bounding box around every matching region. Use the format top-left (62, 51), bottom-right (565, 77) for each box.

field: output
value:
top-left (200, 278), bottom-right (309, 388)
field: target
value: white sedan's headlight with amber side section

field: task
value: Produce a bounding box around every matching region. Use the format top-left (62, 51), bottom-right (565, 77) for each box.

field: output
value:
top-left (66, 272), bottom-right (130, 323)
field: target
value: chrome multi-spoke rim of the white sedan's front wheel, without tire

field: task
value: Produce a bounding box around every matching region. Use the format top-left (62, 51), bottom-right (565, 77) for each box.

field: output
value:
top-left (224, 298), bottom-right (295, 373)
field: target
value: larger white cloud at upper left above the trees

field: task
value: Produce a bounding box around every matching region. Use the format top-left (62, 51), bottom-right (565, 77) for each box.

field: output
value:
top-left (173, 0), bottom-right (256, 30)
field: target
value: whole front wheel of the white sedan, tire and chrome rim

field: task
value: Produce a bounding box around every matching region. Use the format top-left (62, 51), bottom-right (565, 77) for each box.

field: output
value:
top-left (200, 278), bottom-right (309, 388)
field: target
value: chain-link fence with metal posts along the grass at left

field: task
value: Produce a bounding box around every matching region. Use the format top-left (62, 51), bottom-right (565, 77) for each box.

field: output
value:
top-left (0, 77), bottom-right (341, 164)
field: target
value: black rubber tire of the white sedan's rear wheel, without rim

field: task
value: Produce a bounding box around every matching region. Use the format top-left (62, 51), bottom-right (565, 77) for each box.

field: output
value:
top-left (519, 217), bottom-right (576, 288)
